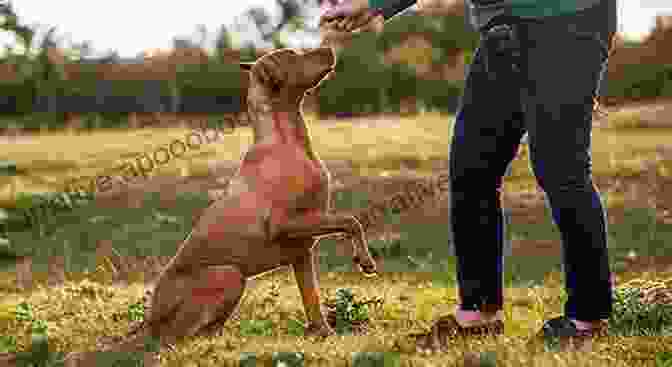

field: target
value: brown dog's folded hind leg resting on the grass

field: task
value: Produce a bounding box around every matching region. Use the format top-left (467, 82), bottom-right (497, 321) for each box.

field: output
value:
top-left (149, 265), bottom-right (245, 345)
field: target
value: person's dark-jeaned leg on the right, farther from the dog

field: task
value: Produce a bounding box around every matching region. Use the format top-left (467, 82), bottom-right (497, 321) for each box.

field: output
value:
top-left (520, 1), bottom-right (612, 328)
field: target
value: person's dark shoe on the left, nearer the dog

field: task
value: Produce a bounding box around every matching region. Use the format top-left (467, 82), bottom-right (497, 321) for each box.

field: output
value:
top-left (410, 315), bottom-right (504, 350)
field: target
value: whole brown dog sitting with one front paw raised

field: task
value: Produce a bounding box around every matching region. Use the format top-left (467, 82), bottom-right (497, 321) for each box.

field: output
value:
top-left (107, 48), bottom-right (376, 356)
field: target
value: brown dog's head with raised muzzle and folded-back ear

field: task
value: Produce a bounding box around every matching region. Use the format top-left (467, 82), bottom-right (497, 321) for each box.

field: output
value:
top-left (240, 47), bottom-right (336, 103)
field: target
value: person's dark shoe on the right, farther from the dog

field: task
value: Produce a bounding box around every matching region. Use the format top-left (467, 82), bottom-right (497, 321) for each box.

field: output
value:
top-left (534, 316), bottom-right (607, 350)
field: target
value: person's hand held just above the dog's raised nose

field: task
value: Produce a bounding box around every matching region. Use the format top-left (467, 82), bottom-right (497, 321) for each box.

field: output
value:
top-left (320, 0), bottom-right (382, 32)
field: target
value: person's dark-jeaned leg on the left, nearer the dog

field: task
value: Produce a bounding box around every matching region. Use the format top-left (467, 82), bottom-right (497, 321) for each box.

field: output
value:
top-left (450, 30), bottom-right (524, 326)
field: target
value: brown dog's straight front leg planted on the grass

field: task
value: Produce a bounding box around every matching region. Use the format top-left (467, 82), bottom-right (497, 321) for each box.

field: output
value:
top-left (292, 246), bottom-right (334, 336)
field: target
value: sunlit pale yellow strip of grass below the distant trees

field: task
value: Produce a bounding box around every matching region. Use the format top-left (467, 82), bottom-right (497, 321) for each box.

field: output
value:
top-left (0, 114), bottom-right (672, 202)
